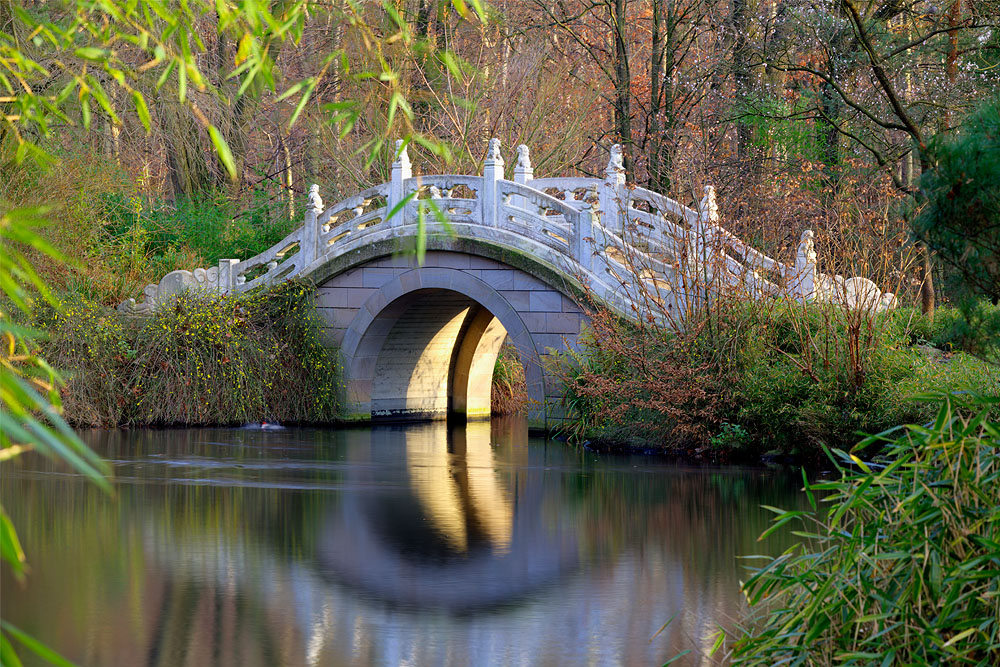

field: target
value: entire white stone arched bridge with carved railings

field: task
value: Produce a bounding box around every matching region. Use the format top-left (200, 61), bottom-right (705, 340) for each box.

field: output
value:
top-left (121, 139), bottom-right (893, 428)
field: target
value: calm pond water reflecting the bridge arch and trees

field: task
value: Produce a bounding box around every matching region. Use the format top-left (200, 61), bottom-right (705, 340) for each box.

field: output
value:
top-left (0, 419), bottom-right (804, 667)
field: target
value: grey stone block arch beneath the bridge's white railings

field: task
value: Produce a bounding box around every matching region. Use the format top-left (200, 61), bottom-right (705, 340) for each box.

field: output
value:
top-left (332, 260), bottom-right (568, 427)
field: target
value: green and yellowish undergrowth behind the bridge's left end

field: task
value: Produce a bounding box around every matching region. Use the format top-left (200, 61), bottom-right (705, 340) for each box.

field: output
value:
top-left (0, 147), bottom-right (301, 306)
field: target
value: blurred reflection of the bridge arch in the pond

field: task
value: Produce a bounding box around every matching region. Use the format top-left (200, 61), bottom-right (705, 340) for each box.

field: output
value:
top-left (317, 422), bottom-right (580, 611)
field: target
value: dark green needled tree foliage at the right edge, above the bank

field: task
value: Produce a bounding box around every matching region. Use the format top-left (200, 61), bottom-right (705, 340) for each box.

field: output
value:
top-left (912, 98), bottom-right (1000, 300)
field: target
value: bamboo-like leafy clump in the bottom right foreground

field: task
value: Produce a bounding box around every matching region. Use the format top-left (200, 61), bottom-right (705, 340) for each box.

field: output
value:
top-left (733, 395), bottom-right (1000, 666)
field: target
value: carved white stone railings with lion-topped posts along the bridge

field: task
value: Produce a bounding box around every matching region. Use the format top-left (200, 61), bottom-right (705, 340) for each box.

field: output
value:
top-left (120, 139), bottom-right (894, 316)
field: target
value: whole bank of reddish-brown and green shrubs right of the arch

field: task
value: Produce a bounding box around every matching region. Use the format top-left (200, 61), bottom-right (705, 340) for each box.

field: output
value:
top-left (561, 303), bottom-right (1000, 462)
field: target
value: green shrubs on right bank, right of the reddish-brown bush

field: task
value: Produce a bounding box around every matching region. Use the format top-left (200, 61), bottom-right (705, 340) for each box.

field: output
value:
top-left (732, 306), bottom-right (1000, 455)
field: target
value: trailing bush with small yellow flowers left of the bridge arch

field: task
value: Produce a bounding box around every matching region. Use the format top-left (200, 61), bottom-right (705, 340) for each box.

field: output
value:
top-left (44, 281), bottom-right (341, 426)
